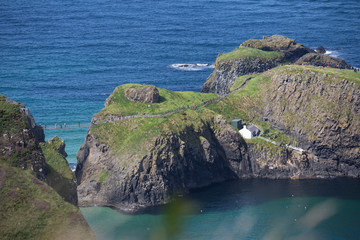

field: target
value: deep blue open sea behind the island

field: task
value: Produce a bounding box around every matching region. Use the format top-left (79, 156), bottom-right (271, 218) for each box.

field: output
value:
top-left (0, 0), bottom-right (360, 239)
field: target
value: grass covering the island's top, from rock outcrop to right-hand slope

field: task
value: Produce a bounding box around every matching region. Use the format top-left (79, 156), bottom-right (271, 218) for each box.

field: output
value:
top-left (91, 65), bottom-right (360, 159)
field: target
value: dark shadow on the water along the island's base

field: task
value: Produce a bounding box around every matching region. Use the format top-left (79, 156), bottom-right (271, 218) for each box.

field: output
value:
top-left (113, 178), bottom-right (360, 215)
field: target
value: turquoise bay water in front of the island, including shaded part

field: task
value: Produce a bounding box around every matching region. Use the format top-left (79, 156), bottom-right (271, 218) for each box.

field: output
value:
top-left (81, 179), bottom-right (360, 240)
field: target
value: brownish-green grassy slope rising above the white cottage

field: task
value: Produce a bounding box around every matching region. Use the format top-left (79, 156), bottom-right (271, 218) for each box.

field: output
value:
top-left (208, 65), bottom-right (360, 146)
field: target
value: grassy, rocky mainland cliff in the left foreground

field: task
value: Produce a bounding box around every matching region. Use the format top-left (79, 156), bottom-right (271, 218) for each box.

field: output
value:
top-left (0, 95), bottom-right (95, 239)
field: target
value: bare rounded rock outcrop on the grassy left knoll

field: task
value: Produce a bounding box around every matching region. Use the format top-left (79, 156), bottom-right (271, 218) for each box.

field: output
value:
top-left (125, 86), bottom-right (159, 103)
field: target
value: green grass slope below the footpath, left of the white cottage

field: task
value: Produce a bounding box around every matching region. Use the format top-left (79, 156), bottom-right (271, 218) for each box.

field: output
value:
top-left (90, 109), bottom-right (219, 166)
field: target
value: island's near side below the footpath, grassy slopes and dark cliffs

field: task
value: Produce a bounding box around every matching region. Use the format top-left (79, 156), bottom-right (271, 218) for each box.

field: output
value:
top-left (76, 65), bottom-right (360, 209)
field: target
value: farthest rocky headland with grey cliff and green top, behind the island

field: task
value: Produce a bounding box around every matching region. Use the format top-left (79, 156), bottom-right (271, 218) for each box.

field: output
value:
top-left (201, 35), bottom-right (318, 93)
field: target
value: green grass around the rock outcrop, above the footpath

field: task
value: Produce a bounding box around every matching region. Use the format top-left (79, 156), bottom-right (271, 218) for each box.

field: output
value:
top-left (95, 84), bottom-right (217, 121)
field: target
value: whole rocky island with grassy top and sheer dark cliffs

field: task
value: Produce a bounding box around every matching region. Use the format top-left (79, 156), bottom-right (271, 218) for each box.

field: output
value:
top-left (76, 35), bottom-right (360, 210)
